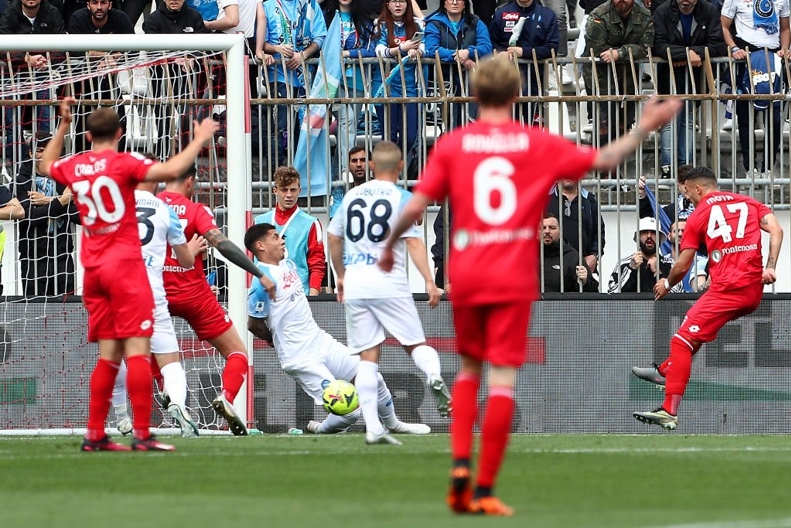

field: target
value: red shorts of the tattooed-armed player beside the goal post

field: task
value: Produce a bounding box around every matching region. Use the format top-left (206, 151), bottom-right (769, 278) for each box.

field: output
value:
top-left (166, 281), bottom-right (233, 341)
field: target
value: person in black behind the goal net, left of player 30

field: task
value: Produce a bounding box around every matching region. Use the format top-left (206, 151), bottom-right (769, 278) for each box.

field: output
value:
top-left (14, 132), bottom-right (79, 297)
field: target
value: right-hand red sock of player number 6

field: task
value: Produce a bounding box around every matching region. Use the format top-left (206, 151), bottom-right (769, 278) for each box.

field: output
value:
top-left (476, 387), bottom-right (514, 488)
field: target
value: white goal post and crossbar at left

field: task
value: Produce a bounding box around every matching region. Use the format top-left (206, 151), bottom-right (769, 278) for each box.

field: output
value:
top-left (0, 34), bottom-right (253, 429)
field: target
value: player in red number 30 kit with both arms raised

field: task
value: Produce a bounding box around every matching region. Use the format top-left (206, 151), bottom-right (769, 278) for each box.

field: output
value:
top-left (40, 97), bottom-right (218, 451)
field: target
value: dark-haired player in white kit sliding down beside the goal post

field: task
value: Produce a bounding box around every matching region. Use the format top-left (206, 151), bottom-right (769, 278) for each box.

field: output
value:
top-left (244, 223), bottom-right (431, 434)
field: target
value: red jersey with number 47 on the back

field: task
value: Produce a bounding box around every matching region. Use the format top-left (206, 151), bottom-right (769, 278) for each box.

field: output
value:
top-left (680, 191), bottom-right (772, 291)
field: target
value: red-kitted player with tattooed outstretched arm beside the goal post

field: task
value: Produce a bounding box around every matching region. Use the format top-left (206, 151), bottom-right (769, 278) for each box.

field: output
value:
top-left (158, 167), bottom-right (275, 435)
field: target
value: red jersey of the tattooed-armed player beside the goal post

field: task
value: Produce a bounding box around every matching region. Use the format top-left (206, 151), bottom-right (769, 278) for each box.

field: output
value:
top-left (157, 191), bottom-right (218, 293)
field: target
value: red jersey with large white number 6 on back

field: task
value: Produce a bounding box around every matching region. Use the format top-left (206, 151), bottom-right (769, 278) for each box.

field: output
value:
top-left (416, 121), bottom-right (596, 306)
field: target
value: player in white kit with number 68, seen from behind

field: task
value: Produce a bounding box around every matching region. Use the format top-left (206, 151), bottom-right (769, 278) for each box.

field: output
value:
top-left (327, 141), bottom-right (451, 444)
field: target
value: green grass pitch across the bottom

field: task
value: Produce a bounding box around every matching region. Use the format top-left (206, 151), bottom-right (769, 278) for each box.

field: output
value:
top-left (0, 434), bottom-right (791, 528)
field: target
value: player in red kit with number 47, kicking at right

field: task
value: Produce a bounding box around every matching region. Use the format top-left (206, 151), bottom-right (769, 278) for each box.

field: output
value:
top-left (632, 167), bottom-right (783, 429)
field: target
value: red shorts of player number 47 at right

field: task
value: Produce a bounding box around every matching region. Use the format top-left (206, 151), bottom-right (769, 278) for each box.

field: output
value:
top-left (677, 282), bottom-right (764, 343)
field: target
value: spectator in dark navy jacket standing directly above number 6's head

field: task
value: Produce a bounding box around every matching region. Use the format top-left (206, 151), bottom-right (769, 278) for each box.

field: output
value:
top-left (489, 0), bottom-right (560, 123)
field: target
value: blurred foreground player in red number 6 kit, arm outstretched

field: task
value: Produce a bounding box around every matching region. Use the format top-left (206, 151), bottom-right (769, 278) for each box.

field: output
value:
top-left (379, 55), bottom-right (680, 515)
